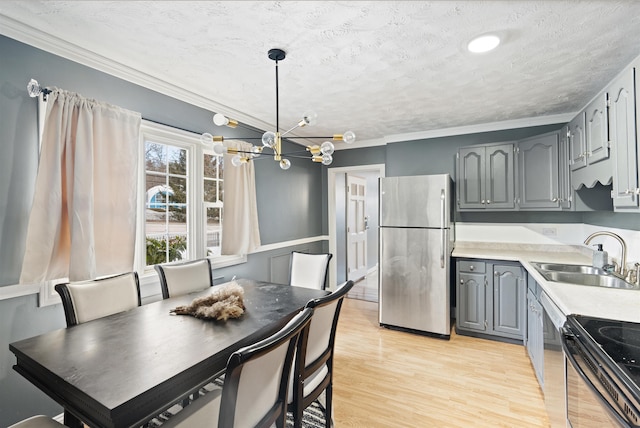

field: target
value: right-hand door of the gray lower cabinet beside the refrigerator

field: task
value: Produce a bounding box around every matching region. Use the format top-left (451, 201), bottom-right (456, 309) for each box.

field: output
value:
top-left (493, 265), bottom-right (526, 339)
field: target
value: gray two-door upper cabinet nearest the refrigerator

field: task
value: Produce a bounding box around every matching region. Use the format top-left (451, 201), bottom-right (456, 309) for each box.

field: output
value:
top-left (456, 143), bottom-right (515, 210)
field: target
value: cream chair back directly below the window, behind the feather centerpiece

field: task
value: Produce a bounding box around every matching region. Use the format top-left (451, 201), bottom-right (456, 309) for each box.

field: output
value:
top-left (154, 259), bottom-right (213, 299)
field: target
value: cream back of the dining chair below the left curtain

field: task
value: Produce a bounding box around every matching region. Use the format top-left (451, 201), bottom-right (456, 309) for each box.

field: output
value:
top-left (55, 272), bottom-right (141, 327)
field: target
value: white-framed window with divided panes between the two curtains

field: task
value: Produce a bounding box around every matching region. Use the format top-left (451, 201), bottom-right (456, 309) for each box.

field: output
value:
top-left (137, 121), bottom-right (246, 272)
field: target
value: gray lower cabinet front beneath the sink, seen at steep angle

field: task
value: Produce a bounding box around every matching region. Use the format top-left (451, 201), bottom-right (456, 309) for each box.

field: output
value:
top-left (525, 277), bottom-right (544, 387)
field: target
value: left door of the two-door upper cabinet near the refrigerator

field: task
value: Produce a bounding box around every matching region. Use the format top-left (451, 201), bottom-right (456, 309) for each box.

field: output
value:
top-left (457, 147), bottom-right (486, 209)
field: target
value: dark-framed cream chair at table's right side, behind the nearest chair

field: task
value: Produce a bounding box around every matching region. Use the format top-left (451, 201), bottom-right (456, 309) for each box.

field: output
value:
top-left (288, 281), bottom-right (353, 428)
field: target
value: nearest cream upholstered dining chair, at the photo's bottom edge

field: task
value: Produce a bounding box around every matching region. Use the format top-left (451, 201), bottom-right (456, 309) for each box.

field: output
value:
top-left (162, 308), bottom-right (313, 428)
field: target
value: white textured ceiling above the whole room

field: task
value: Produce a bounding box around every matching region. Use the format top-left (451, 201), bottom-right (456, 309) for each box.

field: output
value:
top-left (0, 0), bottom-right (640, 147)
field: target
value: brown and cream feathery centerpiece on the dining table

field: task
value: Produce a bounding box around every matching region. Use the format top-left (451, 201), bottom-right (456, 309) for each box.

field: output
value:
top-left (169, 281), bottom-right (245, 321)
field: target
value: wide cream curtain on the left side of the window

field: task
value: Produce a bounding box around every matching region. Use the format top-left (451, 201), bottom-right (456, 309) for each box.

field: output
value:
top-left (20, 89), bottom-right (141, 283)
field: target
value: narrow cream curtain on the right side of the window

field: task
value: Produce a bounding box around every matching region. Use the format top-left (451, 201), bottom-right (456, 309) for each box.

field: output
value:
top-left (221, 140), bottom-right (260, 255)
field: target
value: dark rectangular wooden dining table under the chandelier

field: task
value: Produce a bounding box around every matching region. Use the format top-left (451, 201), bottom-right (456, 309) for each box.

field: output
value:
top-left (9, 279), bottom-right (329, 428)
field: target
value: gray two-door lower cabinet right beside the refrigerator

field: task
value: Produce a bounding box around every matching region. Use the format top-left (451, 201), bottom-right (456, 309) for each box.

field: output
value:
top-left (456, 259), bottom-right (526, 340)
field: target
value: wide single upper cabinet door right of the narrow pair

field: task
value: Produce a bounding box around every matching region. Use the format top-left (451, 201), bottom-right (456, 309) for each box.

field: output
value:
top-left (518, 132), bottom-right (560, 209)
